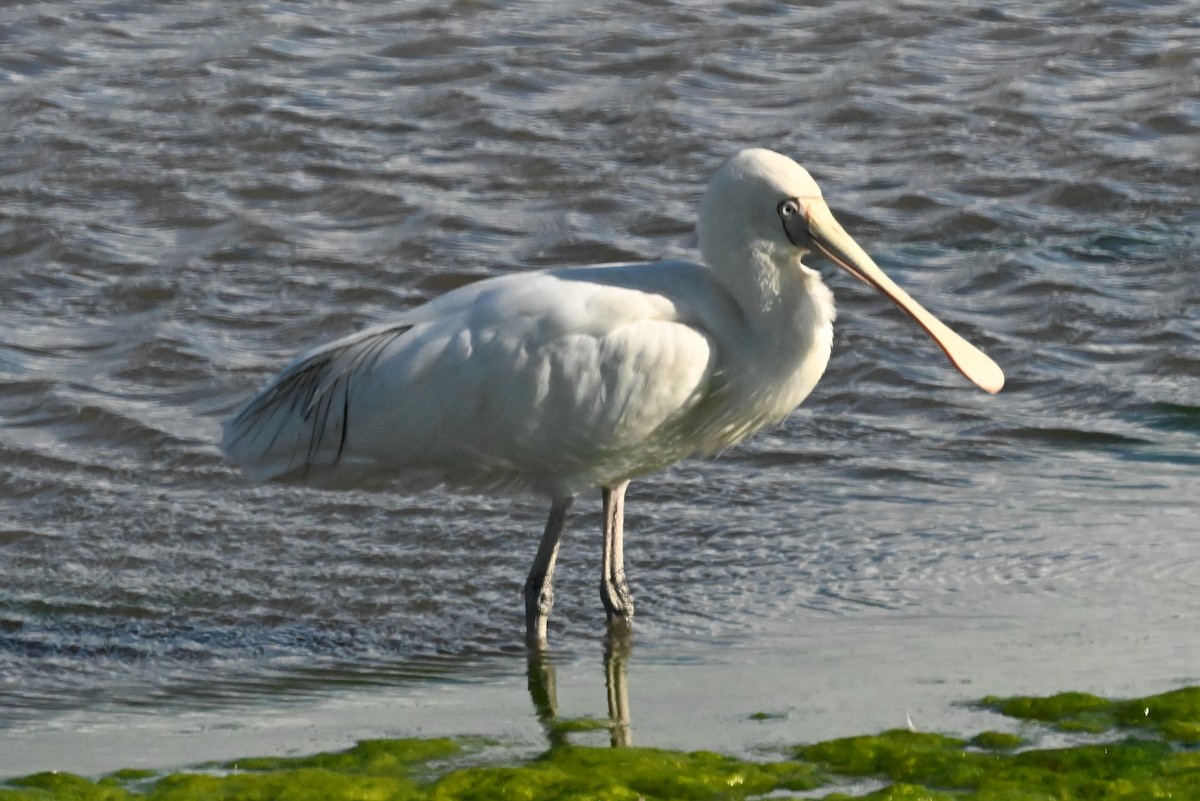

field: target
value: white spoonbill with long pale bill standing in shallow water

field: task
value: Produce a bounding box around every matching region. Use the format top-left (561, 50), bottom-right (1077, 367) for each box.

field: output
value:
top-left (223, 150), bottom-right (1004, 646)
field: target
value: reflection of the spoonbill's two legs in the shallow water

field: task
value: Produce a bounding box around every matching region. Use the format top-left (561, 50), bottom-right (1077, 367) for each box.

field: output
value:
top-left (528, 620), bottom-right (632, 748)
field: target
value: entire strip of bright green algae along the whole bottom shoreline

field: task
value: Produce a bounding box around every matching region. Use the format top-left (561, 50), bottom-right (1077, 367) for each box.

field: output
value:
top-left (0, 687), bottom-right (1200, 801)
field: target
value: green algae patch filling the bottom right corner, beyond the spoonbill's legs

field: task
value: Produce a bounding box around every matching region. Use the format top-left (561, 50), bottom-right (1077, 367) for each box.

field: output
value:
top-left (796, 687), bottom-right (1200, 801)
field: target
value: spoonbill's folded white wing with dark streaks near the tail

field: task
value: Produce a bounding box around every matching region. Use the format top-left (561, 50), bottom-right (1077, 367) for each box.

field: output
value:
top-left (224, 265), bottom-right (734, 492)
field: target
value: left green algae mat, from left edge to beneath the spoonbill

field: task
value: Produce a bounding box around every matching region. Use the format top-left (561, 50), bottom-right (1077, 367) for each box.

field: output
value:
top-left (0, 740), bottom-right (820, 801)
